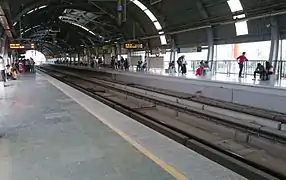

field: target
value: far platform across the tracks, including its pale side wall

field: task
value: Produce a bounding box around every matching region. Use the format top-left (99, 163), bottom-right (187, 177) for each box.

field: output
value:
top-left (46, 65), bottom-right (286, 113)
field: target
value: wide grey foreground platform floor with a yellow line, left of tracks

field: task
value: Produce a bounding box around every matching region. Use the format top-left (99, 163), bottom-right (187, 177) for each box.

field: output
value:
top-left (0, 74), bottom-right (245, 180)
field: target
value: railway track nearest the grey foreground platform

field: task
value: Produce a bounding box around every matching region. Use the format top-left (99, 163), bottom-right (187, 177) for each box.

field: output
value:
top-left (38, 66), bottom-right (286, 179)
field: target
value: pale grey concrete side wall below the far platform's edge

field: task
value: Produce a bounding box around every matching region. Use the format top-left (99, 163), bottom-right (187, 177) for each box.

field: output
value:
top-left (113, 73), bottom-right (286, 113)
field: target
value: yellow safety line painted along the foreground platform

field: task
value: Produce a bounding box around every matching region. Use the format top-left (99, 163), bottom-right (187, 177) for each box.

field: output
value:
top-left (43, 74), bottom-right (188, 180)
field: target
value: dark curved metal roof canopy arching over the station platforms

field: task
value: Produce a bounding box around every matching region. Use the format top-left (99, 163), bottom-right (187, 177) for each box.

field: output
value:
top-left (4, 0), bottom-right (286, 53)
